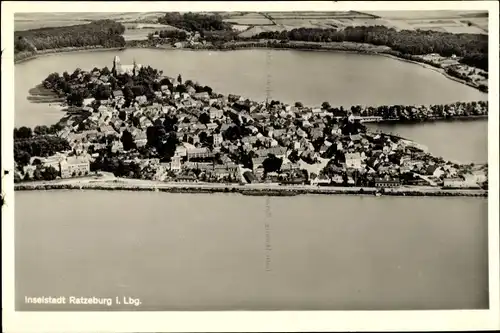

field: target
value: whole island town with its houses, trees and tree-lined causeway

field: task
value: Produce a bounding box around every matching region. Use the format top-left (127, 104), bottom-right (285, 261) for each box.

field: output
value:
top-left (14, 57), bottom-right (488, 189)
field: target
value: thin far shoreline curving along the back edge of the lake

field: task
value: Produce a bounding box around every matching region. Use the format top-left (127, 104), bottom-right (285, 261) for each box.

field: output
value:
top-left (14, 43), bottom-right (488, 94)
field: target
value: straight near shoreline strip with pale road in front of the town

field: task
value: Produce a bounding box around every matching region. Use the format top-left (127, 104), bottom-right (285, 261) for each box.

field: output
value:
top-left (14, 179), bottom-right (488, 197)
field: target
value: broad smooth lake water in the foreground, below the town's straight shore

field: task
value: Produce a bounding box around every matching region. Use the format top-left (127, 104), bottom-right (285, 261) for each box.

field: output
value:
top-left (15, 191), bottom-right (488, 310)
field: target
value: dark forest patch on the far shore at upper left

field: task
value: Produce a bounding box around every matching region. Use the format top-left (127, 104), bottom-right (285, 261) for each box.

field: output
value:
top-left (14, 20), bottom-right (125, 53)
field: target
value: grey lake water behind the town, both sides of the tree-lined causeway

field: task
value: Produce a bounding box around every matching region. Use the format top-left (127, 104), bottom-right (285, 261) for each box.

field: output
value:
top-left (15, 49), bottom-right (488, 162)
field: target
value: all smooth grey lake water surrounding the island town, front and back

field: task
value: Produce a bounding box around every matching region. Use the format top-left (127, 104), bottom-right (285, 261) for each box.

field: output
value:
top-left (15, 49), bottom-right (488, 310)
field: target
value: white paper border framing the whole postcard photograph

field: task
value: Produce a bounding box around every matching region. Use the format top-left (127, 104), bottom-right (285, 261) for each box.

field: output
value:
top-left (1, 1), bottom-right (500, 332)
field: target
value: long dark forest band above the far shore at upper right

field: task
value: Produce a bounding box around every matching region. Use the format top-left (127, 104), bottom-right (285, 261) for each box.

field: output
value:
top-left (251, 26), bottom-right (488, 71)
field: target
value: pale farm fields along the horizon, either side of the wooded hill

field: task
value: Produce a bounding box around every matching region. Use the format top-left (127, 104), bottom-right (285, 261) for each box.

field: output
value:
top-left (14, 11), bottom-right (488, 35)
